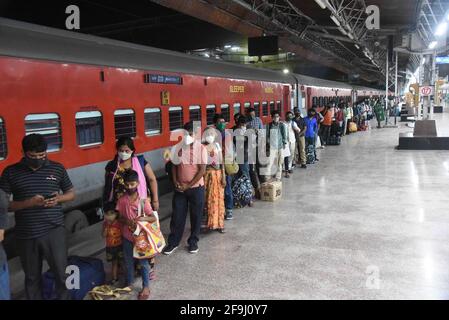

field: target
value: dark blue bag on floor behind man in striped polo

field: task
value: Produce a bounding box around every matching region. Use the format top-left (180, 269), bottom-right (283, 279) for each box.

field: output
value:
top-left (42, 256), bottom-right (106, 300)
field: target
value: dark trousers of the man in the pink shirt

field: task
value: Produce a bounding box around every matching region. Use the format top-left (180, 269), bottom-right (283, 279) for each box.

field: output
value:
top-left (168, 187), bottom-right (205, 246)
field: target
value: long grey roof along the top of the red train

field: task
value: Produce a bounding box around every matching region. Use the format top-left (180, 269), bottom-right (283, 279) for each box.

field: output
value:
top-left (0, 18), bottom-right (374, 90)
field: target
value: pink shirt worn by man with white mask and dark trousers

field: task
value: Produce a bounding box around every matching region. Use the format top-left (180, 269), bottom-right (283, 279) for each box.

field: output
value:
top-left (176, 142), bottom-right (207, 188)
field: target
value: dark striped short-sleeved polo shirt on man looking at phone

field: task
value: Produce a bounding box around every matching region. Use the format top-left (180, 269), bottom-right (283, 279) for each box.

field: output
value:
top-left (0, 159), bottom-right (73, 239)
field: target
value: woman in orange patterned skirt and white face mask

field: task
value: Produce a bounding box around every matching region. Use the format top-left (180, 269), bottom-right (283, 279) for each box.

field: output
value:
top-left (204, 129), bottom-right (226, 233)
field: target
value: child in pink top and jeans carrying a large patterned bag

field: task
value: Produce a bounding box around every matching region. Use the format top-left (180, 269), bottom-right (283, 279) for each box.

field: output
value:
top-left (116, 170), bottom-right (156, 300)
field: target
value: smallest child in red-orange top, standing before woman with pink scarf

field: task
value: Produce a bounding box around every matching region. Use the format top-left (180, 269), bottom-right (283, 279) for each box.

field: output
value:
top-left (103, 203), bottom-right (123, 285)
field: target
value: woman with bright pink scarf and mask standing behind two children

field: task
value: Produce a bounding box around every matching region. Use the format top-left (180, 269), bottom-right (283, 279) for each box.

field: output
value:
top-left (103, 137), bottom-right (159, 211)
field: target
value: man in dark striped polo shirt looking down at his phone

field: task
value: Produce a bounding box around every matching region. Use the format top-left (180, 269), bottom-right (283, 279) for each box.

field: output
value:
top-left (0, 134), bottom-right (75, 300)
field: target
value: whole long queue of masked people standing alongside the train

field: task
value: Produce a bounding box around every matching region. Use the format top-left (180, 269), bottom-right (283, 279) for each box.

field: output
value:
top-left (0, 104), bottom-right (376, 300)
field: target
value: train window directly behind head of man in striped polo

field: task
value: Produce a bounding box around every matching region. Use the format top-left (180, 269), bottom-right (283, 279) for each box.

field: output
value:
top-left (25, 113), bottom-right (62, 152)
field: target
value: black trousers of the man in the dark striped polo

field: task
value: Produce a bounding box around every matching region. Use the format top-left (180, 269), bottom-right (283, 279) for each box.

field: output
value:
top-left (17, 226), bottom-right (70, 300)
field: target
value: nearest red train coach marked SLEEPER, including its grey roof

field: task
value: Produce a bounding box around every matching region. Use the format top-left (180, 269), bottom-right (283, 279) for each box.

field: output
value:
top-left (0, 19), bottom-right (293, 222)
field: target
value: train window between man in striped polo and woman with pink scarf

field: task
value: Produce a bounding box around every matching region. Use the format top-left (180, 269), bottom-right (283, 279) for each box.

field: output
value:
top-left (75, 111), bottom-right (104, 147)
